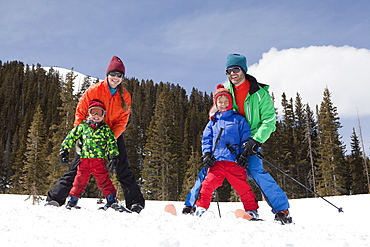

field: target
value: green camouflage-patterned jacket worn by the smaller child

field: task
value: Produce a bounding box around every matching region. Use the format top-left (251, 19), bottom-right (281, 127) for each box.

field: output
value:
top-left (62, 120), bottom-right (119, 159)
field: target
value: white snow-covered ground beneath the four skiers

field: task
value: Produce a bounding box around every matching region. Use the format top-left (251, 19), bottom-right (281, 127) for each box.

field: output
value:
top-left (0, 194), bottom-right (370, 247)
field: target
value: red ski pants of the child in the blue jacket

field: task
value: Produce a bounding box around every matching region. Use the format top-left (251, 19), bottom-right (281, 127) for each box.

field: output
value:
top-left (196, 161), bottom-right (258, 211)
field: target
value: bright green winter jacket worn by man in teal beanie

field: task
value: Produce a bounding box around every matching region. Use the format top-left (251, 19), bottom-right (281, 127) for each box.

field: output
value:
top-left (225, 74), bottom-right (276, 143)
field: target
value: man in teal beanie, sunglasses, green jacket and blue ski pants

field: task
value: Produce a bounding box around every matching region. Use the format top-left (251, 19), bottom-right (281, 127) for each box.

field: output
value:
top-left (225, 54), bottom-right (292, 223)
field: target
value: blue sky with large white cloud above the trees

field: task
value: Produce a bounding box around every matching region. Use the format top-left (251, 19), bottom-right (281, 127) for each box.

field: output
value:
top-left (0, 0), bottom-right (370, 154)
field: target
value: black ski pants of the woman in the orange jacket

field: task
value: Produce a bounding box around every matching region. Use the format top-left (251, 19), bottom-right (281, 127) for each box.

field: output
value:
top-left (46, 134), bottom-right (145, 209)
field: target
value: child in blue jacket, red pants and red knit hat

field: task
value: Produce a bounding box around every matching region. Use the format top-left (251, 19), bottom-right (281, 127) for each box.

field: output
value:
top-left (195, 84), bottom-right (258, 216)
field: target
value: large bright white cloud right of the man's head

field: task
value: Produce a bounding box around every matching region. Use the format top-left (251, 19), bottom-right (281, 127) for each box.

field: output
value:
top-left (248, 46), bottom-right (370, 117)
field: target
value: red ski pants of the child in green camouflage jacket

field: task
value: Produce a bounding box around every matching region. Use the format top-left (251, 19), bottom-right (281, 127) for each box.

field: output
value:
top-left (70, 158), bottom-right (117, 198)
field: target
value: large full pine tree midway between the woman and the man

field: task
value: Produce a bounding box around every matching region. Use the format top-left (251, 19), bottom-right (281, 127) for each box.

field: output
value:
top-left (142, 89), bottom-right (181, 200)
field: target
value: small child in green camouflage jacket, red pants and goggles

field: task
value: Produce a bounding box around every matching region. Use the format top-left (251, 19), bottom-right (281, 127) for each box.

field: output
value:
top-left (60, 100), bottom-right (119, 210)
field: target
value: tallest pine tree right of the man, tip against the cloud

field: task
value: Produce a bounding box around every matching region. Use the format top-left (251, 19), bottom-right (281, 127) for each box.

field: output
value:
top-left (317, 88), bottom-right (347, 196)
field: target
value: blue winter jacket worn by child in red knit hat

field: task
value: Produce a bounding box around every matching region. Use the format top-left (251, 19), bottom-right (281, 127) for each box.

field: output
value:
top-left (202, 110), bottom-right (251, 162)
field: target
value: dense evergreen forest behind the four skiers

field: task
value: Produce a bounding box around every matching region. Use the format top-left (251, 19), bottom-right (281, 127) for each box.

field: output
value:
top-left (0, 61), bottom-right (370, 201)
